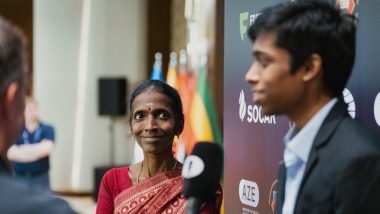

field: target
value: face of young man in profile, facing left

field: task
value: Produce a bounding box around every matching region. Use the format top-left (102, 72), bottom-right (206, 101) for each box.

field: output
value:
top-left (245, 32), bottom-right (305, 115)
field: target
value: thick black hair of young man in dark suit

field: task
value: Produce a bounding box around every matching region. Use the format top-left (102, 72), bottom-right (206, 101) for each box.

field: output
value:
top-left (248, 0), bottom-right (356, 97)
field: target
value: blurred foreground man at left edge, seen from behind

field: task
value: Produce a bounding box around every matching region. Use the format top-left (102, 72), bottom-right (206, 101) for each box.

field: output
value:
top-left (0, 17), bottom-right (74, 214)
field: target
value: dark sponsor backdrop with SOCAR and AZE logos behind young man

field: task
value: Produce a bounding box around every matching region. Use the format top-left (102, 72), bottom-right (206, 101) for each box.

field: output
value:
top-left (224, 0), bottom-right (380, 214)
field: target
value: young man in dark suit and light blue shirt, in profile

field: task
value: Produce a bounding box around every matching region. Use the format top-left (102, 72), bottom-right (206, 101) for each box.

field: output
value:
top-left (245, 1), bottom-right (380, 214)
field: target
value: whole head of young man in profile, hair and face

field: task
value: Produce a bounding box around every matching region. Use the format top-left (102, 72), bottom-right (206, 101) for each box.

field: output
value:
top-left (246, 0), bottom-right (355, 117)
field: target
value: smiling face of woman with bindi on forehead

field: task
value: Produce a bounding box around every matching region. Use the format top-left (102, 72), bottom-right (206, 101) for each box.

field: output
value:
top-left (131, 89), bottom-right (175, 154)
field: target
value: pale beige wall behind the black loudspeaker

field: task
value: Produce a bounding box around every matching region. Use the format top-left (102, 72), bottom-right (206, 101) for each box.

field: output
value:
top-left (34, 0), bottom-right (147, 192)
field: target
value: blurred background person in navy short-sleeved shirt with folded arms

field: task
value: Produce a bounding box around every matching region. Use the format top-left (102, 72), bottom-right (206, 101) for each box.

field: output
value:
top-left (7, 97), bottom-right (54, 191)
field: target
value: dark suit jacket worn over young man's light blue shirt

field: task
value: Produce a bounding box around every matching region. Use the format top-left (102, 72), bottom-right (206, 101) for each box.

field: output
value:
top-left (276, 99), bottom-right (380, 214)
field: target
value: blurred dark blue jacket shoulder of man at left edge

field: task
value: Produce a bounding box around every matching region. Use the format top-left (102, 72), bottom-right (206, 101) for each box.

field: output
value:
top-left (0, 157), bottom-right (75, 214)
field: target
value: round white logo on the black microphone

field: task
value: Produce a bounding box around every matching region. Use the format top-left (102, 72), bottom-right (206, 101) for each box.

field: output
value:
top-left (182, 155), bottom-right (205, 179)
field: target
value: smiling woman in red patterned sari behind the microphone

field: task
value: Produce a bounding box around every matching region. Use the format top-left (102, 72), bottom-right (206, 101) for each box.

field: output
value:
top-left (96, 80), bottom-right (222, 214)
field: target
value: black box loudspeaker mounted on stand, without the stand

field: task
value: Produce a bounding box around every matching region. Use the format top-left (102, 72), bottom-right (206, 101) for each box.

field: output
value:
top-left (98, 77), bottom-right (127, 116)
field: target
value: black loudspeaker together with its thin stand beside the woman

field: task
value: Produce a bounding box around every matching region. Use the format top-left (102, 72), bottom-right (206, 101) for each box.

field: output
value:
top-left (93, 77), bottom-right (127, 201)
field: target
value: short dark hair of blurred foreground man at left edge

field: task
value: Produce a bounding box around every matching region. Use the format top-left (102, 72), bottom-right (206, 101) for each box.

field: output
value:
top-left (0, 16), bottom-right (26, 99)
